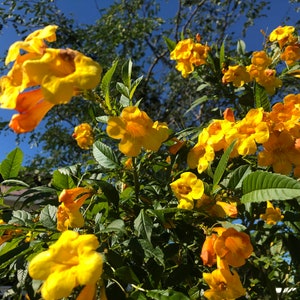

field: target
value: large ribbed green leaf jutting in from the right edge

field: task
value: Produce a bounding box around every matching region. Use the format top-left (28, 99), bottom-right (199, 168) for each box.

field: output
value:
top-left (241, 171), bottom-right (300, 203)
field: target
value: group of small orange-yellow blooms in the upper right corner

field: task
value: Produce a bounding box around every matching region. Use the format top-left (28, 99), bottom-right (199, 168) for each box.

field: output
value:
top-left (222, 26), bottom-right (300, 95)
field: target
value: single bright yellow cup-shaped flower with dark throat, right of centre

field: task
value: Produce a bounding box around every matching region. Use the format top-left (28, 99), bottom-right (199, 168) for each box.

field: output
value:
top-left (170, 172), bottom-right (204, 209)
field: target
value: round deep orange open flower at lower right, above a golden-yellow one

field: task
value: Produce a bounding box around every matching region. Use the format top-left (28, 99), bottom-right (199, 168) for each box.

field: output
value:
top-left (214, 228), bottom-right (253, 267)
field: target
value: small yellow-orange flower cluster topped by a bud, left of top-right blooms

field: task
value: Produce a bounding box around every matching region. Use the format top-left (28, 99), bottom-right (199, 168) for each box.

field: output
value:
top-left (171, 37), bottom-right (210, 78)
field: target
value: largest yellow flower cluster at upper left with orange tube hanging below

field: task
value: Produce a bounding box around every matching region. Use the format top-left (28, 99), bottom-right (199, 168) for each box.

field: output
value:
top-left (0, 25), bottom-right (102, 133)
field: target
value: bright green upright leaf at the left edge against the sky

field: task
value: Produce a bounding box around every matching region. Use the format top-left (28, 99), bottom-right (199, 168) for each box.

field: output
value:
top-left (0, 148), bottom-right (23, 179)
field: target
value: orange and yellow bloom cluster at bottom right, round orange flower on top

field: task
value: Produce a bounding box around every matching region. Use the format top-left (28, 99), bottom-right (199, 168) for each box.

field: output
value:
top-left (201, 227), bottom-right (253, 300)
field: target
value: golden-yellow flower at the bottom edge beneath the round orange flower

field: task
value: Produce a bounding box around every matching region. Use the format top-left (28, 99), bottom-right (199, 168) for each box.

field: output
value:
top-left (203, 269), bottom-right (246, 300)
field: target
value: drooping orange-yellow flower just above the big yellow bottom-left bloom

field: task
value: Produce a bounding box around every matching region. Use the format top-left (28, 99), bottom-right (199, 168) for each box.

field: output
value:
top-left (57, 187), bottom-right (92, 231)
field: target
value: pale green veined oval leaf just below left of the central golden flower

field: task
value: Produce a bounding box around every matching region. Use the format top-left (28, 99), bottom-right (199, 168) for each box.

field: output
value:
top-left (93, 141), bottom-right (119, 170)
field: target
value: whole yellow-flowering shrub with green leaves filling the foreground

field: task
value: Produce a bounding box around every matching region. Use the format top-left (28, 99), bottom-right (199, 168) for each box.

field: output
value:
top-left (0, 25), bottom-right (300, 300)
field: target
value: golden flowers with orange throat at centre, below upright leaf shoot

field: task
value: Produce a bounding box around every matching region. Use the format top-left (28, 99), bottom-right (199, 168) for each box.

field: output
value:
top-left (106, 106), bottom-right (169, 156)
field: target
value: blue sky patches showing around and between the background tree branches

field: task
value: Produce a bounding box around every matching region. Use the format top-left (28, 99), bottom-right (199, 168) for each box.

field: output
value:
top-left (0, 0), bottom-right (300, 162)
